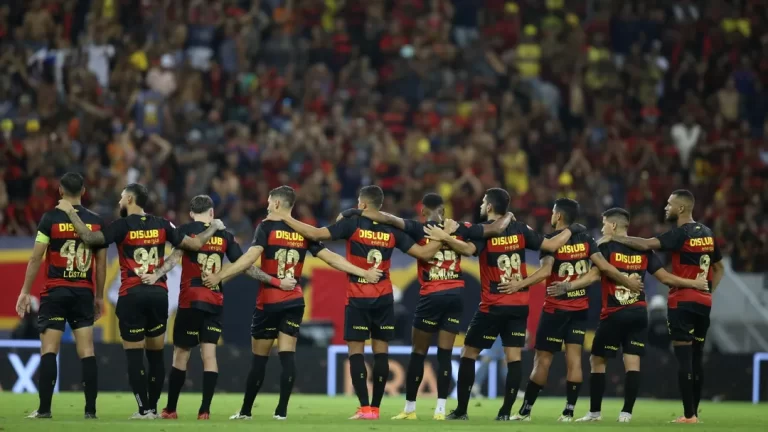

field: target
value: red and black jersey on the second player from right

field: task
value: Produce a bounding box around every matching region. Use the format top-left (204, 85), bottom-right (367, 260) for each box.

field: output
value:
top-left (599, 242), bottom-right (664, 319)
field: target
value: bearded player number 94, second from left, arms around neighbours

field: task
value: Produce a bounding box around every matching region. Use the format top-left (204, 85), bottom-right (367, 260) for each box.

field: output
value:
top-left (56, 183), bottom-right (224, 420)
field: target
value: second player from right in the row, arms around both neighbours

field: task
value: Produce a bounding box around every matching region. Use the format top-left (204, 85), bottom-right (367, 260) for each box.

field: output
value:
top-left (547, 208), bottom-right (708, 423)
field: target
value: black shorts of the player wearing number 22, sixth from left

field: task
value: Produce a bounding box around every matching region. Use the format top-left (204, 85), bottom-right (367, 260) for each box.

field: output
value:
top-left (413, 293), bottom-right (464, 334)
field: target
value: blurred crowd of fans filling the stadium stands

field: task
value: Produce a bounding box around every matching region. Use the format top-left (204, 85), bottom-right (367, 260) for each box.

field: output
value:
top-left (0, 0), bottom-right (768, 271)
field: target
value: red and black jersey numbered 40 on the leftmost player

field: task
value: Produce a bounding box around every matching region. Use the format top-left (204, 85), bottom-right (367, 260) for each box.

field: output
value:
top-left (35, 205), bottom-right (104, 296)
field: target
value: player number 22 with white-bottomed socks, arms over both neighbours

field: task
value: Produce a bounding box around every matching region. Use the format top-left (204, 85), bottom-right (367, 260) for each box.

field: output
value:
top-left (342, 193), bottom-right (512, 420)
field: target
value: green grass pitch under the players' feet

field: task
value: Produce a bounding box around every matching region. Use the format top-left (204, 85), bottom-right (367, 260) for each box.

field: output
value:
top-left (0, 392), bottom-right (768, 432)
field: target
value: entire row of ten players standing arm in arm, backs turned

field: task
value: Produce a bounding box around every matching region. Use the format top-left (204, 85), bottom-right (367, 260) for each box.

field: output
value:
top-left (18, 174), bottom-right (719, 420)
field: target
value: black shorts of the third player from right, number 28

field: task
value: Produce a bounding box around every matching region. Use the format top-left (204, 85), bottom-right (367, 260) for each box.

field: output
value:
top-left (536, 309), bottom-right (588, 352)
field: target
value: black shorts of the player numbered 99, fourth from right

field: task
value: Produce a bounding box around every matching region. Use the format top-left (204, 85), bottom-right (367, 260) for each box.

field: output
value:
top-left (464, 306), bottom-right (528, 350)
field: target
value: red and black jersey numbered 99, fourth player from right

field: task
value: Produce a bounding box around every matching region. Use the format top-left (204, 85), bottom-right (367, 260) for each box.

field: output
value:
top-left (473, 221), bottom-right (544, 312)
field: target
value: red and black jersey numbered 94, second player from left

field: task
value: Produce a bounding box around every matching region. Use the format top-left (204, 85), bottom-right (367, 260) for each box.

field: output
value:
top-left (104, 214), bottom-right (184, 296)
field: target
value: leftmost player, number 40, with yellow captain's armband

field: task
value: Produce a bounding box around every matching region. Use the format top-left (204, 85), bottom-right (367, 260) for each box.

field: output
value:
top-left (16, 172), bottom-right (107, 419)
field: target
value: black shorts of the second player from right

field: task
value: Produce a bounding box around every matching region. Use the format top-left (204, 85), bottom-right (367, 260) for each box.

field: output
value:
top-left (592, 307), bottom-right (648, 358)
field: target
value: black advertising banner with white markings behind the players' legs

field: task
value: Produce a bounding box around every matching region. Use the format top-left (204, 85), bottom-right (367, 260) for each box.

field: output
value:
top-left (30, 341), bottom-right (756, 400)
